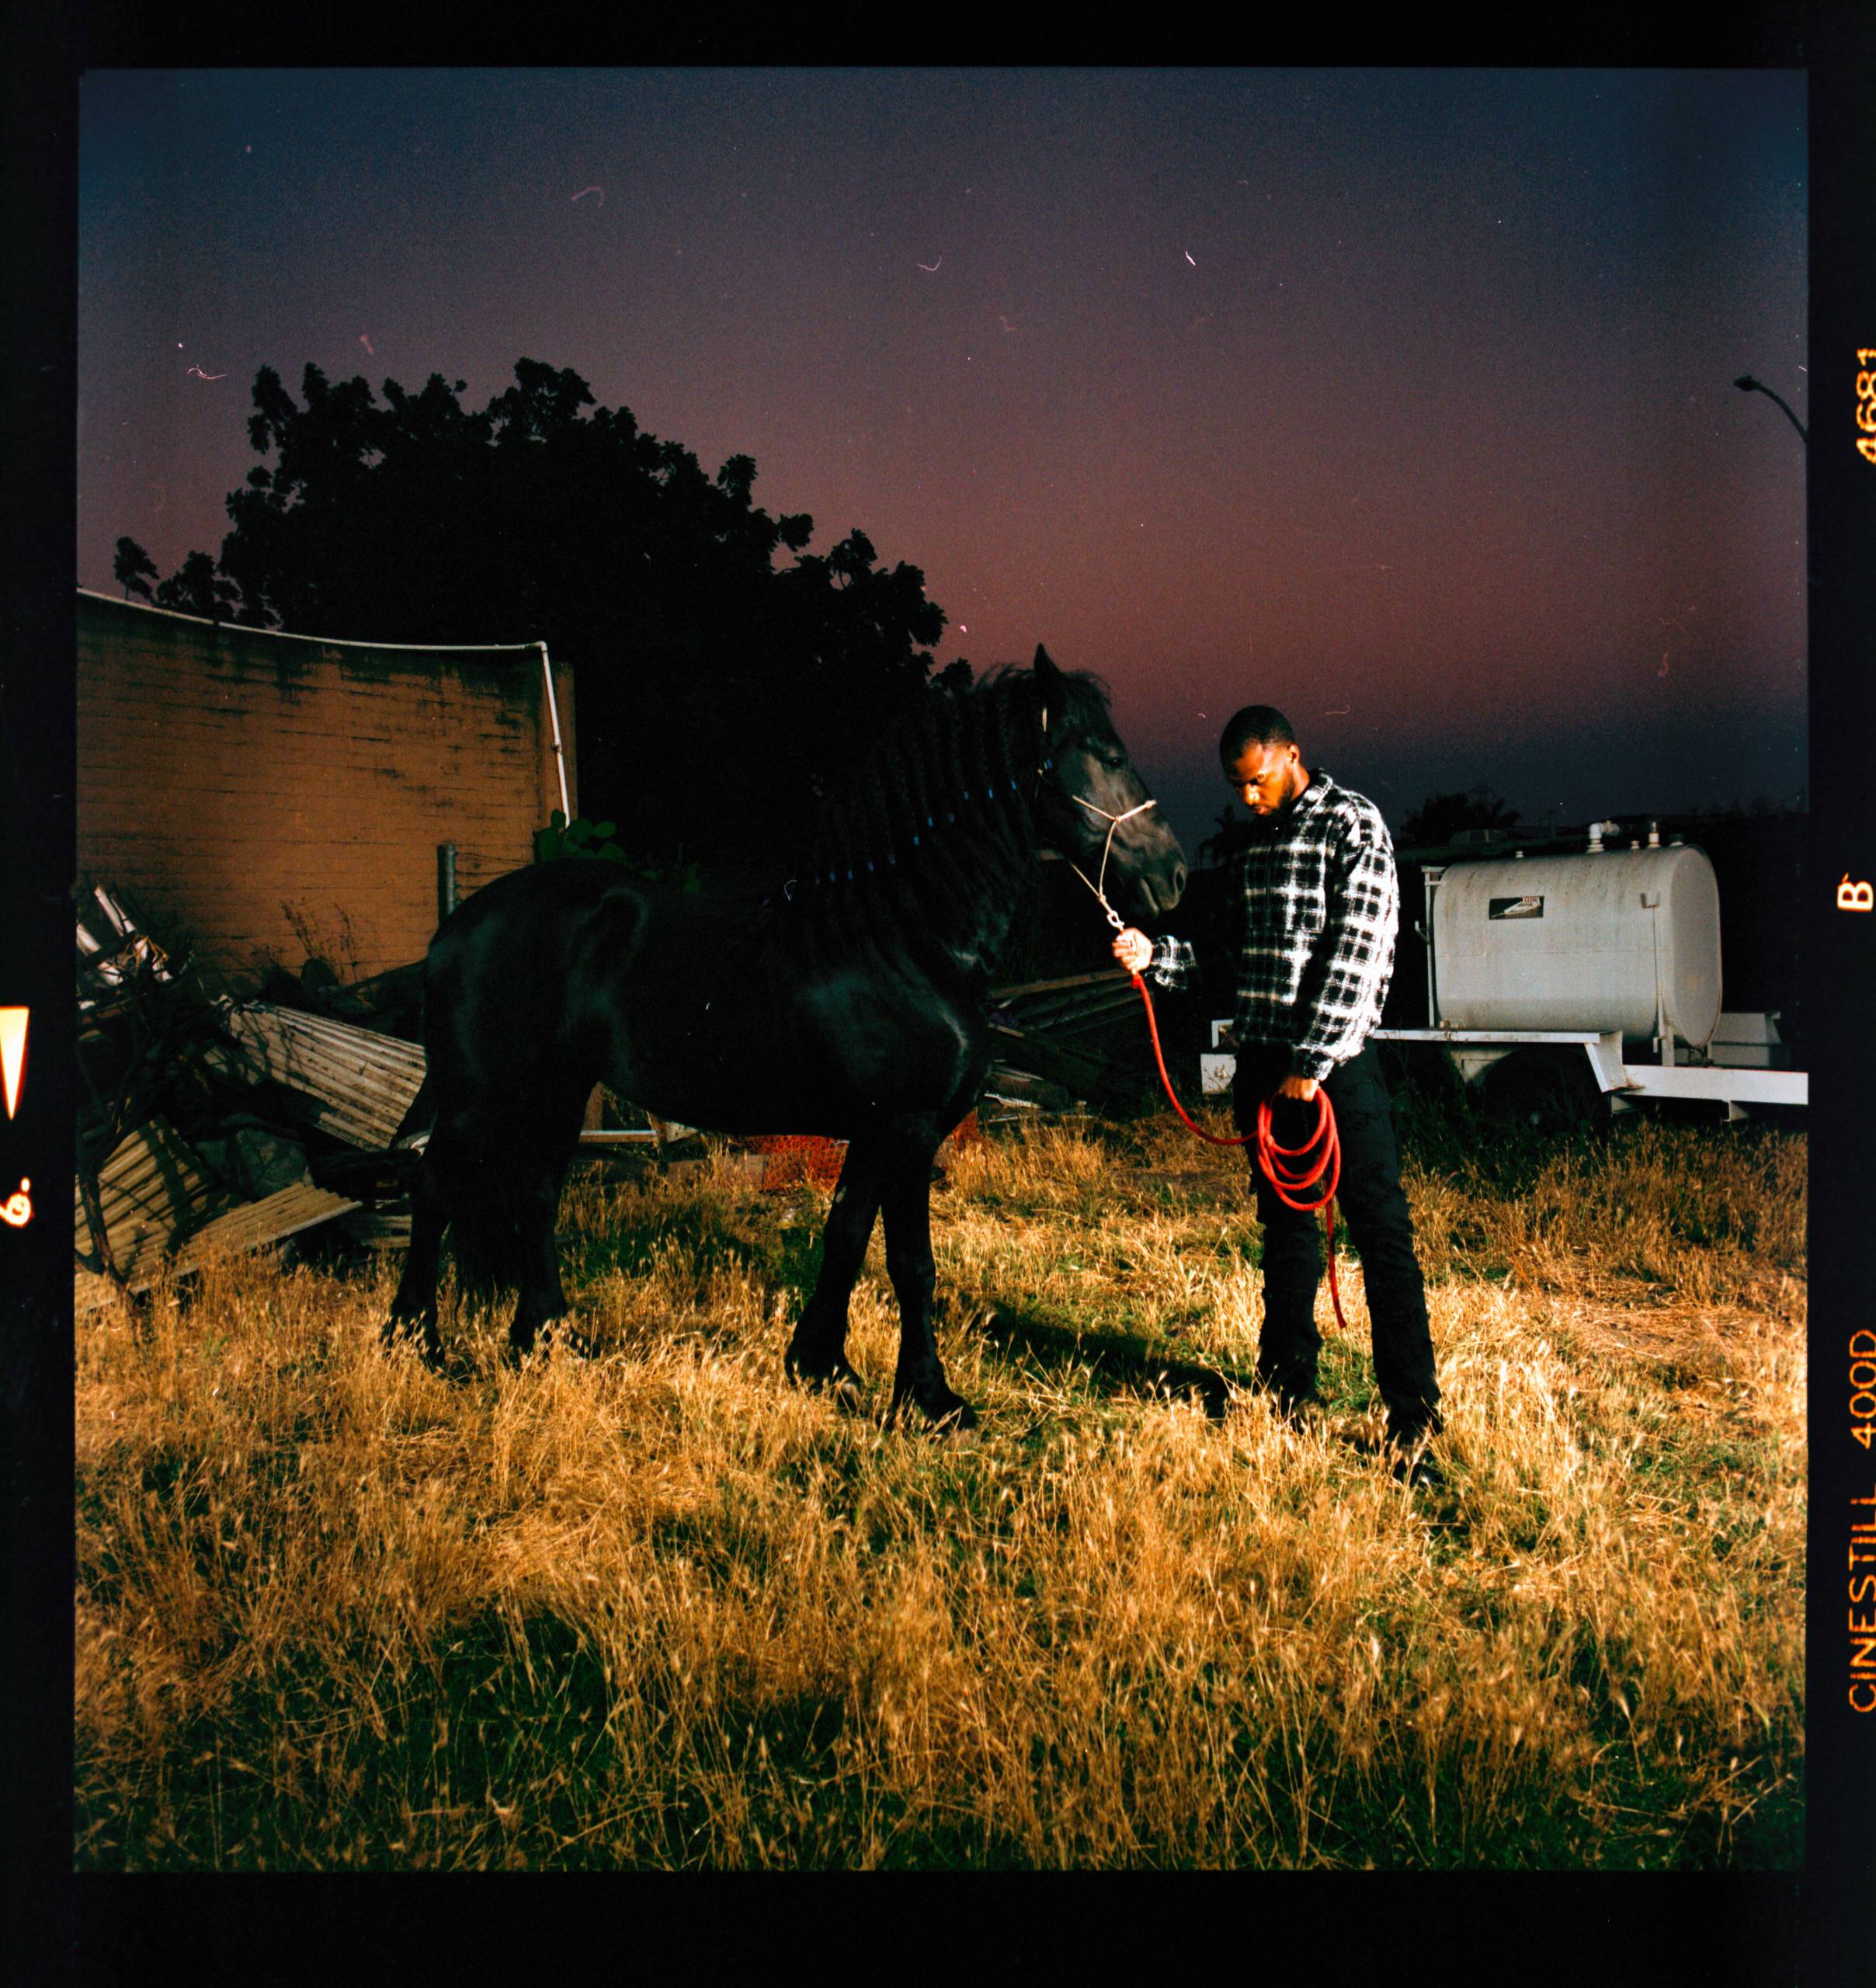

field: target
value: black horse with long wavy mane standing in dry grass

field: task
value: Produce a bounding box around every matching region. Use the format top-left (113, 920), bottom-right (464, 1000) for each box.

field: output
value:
top-left (386, 648), bottom-right (1186, 1426)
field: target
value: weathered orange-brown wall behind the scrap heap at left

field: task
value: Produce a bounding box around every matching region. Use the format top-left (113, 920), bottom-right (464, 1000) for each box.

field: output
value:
top-left (78, 590), bottom-right (578, 978)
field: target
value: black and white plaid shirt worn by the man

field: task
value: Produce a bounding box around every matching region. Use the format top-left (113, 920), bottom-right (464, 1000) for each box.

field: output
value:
top-left (1148, 767), bottom-right (1401, 1082)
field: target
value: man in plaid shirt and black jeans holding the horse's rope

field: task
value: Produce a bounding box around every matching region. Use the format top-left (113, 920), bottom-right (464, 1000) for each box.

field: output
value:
top-left (1113, 704), bottom-right (1441, 1487)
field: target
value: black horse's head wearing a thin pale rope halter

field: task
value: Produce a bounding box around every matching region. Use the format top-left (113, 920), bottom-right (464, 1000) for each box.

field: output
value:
top-left (1035, 644), bottom-right (1186, 919)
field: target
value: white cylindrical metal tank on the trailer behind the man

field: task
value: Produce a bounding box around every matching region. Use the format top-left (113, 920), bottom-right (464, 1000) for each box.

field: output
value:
top-left (1433, 845), bottom-right (1719, 1048)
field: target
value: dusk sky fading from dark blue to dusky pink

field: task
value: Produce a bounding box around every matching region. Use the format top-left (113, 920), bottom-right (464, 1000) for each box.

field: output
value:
top-left (75, 70), bottom-right (1808, 853)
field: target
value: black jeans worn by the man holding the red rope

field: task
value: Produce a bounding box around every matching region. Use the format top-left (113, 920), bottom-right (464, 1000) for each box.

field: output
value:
top-left (1232, 1041), bottom-right (1441, 1441)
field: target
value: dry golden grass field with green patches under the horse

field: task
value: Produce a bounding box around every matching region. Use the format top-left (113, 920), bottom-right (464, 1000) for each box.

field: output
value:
top-left (74, 1081), bottom-right (1805, 1871)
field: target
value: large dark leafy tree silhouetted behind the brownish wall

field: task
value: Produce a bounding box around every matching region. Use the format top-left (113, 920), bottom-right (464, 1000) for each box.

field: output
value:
top-left (120, 358), bottom-right (954, 855)
